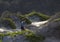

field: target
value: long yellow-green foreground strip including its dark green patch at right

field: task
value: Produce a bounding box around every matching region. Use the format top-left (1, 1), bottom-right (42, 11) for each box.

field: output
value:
top-left (0, 30), bottom-right (45, 42)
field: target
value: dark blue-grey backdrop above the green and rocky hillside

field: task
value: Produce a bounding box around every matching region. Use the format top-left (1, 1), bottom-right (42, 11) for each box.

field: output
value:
top-left (0, 0), bottom-right (60, 15)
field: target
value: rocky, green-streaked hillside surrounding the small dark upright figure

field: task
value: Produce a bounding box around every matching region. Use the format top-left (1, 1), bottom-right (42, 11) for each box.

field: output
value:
top-left (0, 12), bottom-right (60, 42)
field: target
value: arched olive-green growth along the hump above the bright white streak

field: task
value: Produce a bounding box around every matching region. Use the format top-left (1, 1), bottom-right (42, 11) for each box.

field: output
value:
top-left (25, 11), bottom-right (50, 20)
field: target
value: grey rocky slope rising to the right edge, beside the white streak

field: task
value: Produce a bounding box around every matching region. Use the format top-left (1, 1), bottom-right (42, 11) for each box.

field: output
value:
top-left (36, 14), bottom-right (60, 39)
